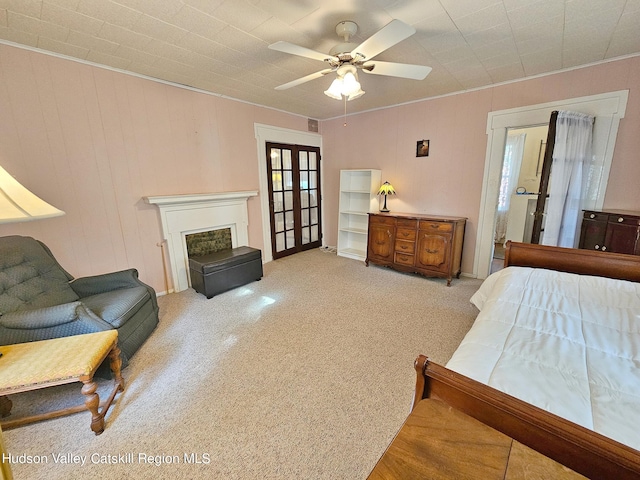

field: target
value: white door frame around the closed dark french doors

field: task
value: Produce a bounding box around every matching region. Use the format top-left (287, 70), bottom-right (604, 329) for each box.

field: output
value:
top-left (254, 123), bottom-right (325, 263)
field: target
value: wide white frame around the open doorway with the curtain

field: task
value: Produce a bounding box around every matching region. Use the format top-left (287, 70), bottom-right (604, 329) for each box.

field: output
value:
top-left (473, 90), bottom-right (629, 278)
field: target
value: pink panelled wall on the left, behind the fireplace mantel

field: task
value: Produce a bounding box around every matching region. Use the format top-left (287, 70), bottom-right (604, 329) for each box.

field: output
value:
top-left (0, 45), bottom-right (307, 291)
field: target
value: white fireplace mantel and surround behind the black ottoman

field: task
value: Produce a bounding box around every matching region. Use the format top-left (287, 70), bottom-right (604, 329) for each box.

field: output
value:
top-left (143, 190), bottom-right (258, 292)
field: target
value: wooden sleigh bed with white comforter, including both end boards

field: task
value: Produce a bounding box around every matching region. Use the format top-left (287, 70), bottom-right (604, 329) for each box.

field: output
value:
top-left (414, 242), bottom-right (640, 478)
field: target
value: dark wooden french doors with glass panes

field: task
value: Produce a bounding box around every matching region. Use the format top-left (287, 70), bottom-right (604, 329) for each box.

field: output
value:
top-left (267, 142), bottom-right (322, 259)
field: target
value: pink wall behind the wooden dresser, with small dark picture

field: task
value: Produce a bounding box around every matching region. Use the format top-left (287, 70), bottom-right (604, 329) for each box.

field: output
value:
top-left (321, 57), bottom-right (640, 272)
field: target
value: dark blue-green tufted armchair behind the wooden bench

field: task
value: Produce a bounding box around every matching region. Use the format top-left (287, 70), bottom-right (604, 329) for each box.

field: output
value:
top-left (0, 235), bottom-right (158, 366)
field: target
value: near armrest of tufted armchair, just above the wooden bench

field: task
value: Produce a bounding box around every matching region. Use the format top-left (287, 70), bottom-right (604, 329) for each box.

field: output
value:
top-left (0, 302), bottom-right (111, 332)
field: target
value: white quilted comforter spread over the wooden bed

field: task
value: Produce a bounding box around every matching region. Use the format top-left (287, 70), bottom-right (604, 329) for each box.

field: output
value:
top-left (447, 267), bottom-right (640, 450)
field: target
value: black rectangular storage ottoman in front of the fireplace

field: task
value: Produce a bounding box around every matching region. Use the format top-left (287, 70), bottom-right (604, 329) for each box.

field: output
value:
top-left (189, 247), bottom-right (262, 298)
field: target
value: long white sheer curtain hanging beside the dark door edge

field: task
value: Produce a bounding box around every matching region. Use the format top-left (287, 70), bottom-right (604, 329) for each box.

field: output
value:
top-left (540, 112), bottom-right (594, 248)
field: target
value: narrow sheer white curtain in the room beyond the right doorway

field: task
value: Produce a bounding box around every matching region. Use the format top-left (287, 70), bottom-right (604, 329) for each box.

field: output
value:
top-left (495, 133), bottom-right (527, 243)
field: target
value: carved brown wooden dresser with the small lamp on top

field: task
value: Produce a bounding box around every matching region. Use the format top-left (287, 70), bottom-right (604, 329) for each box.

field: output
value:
top-left (365, 213), bottom-right (467, 285)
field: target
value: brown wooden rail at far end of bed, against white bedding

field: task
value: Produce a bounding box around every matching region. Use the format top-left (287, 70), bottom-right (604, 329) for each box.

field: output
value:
top-left (504, 241), bottom-right (640, 282)
